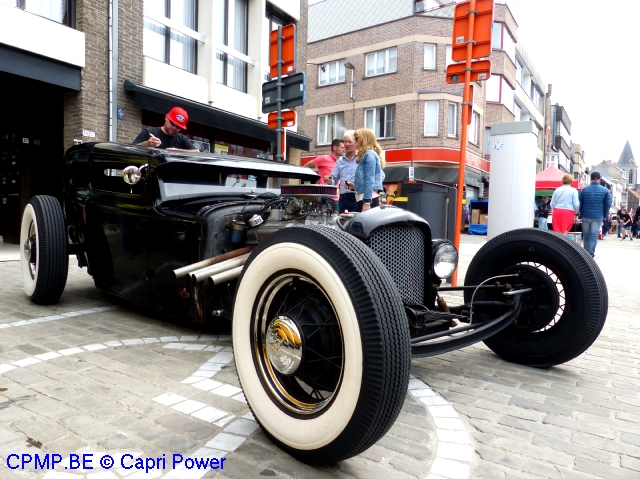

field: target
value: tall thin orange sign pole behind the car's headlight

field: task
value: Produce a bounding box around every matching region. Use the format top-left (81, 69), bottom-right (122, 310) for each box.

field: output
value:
top-left (451, 0), bottom-right (476, 286)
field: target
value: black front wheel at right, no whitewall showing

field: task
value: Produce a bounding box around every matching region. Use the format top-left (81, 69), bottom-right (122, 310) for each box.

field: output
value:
top-left (465, 228), bottom-right (608, 367)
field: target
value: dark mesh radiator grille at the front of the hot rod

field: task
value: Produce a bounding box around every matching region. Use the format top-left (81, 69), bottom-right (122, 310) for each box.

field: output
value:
top-left (367, 226), bottom-right (424, 304)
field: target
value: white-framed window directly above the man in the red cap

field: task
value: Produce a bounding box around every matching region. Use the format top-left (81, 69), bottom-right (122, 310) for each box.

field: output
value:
top-left (143, 0), bottom-right (198, 73)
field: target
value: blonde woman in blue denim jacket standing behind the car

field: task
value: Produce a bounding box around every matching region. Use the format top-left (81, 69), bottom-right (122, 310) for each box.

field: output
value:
top-left (353, 128), bottom-right (384, 212)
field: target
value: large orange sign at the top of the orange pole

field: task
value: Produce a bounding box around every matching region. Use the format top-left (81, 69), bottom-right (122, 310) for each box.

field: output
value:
top-left (451, 0), bottom-right (494, 62)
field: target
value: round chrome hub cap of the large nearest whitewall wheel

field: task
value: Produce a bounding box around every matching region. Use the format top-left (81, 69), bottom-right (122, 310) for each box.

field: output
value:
top-left (266, 316), bottom-right (302, 375)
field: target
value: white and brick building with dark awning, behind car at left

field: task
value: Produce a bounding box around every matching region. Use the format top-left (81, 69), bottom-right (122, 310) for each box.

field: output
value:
top-left (0, 0), bottom-right (311, 240)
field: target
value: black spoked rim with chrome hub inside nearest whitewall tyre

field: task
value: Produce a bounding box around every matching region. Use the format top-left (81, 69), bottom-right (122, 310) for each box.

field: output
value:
top-left (254, 272), bottom-right (344, 415)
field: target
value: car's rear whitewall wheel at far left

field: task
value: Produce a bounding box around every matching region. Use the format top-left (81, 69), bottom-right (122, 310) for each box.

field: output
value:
top-left (20, 196), bottom-right (69, 304)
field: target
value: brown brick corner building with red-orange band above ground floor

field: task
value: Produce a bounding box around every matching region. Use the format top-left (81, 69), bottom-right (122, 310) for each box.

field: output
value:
top-left (303, 0), bottom-right (490, 198)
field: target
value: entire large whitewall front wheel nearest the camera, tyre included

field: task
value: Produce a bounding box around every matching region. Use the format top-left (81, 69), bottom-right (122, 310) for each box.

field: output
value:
top-left (233, 227), bottom-right (411, 465)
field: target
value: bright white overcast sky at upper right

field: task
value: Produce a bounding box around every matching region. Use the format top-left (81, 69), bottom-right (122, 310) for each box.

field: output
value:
top-left (309, 0), bottom-right (640, 166)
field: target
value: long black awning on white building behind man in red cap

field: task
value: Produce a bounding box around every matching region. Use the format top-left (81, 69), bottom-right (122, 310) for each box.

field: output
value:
top-left (124, 80), bottom-right (311, 151)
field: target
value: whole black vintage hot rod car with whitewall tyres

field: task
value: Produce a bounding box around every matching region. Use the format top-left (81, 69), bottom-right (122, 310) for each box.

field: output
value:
top-left (20, 143), bottom-right (608, 464)
